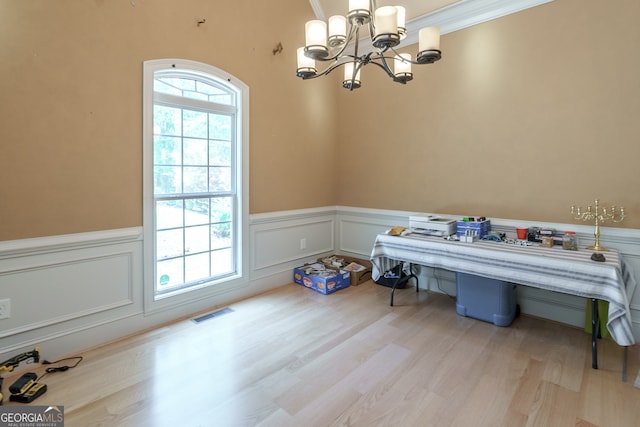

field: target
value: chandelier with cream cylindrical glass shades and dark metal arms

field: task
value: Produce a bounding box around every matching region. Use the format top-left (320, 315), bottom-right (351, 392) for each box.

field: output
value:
top-left (296, 0), bottom-right (441, 90)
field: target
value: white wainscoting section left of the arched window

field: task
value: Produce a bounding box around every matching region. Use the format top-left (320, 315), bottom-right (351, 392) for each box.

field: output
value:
top-left (0, 228), bottom-right (142, 358)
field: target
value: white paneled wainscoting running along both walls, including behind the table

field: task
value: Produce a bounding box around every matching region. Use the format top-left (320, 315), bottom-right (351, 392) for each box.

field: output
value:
top-left (0, 206), bottom-right (640, 358)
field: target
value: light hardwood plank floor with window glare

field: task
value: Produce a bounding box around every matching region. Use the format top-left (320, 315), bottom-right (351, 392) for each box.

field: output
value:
top-left (3, 282), bottom-right (640, 427)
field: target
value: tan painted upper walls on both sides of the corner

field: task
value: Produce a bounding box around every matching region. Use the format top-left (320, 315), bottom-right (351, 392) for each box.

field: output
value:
top-left (0, 0), bottom-right (640, 240)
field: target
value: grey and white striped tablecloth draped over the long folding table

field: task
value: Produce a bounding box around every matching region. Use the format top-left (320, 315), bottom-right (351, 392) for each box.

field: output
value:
top-left (371, 234), bottom-right (636, 346)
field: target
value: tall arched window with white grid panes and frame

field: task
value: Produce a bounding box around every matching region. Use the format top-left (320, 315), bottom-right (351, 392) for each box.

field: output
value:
top-left (144, 60), bottom-right (248, 300)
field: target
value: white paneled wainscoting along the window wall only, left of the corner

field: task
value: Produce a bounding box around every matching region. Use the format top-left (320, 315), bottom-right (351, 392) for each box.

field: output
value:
top-left (0, 206), bottom-right (336, 360)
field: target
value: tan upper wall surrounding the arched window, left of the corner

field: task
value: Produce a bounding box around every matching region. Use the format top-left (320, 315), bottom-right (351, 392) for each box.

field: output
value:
top-left (0, 0), bottom-right (337, 240)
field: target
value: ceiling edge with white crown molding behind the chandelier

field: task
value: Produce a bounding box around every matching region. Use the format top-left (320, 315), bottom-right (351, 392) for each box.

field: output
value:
top-left (309, 0), bottom-right (554, 36)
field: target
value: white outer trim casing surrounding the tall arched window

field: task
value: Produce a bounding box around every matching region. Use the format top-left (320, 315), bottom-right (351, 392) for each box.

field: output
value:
top-left (142, 59), bottom-right (249, 314)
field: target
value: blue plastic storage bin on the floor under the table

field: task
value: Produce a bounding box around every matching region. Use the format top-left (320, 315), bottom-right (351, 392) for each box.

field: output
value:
top-left (456, 272), bottom-right (518, 326)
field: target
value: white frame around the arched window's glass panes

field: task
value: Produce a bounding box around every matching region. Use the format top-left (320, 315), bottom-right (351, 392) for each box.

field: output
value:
top-left (143, 59), bottom-right (249, 313)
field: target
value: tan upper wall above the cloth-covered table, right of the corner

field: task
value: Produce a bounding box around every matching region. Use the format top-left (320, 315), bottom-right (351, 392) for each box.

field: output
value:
top-left (337, 0), bottom-right (640, 228)
